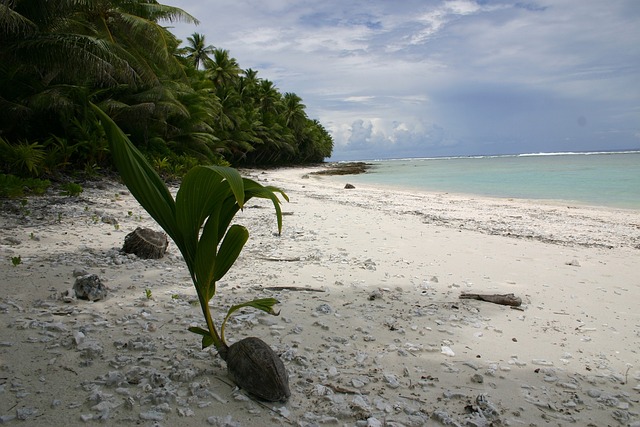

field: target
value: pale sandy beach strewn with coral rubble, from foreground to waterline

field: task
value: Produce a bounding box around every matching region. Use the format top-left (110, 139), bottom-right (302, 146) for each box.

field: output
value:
top-left (0, 169), bottom-right (640, 427)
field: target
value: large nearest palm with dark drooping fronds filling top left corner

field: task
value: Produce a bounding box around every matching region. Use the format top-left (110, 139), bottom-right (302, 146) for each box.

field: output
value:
top-left (0, 0), bottom-right (197, 167)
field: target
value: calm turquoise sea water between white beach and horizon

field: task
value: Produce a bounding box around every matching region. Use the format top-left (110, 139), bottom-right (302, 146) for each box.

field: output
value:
top-left (338, 152), bottom-right (640, 209)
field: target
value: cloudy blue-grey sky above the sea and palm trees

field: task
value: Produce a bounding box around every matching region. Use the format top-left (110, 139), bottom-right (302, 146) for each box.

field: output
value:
top-left (165, 0), bottom-right (640, 160)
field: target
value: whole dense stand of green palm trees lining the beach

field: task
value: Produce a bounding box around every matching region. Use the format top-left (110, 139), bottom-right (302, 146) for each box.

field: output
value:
top-left (0, 0), bottom-right (333, 189)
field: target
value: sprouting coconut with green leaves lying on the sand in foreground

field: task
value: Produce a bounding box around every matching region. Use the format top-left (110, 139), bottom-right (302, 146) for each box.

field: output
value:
top-left (91, 104), bottom-right (290, 401)
